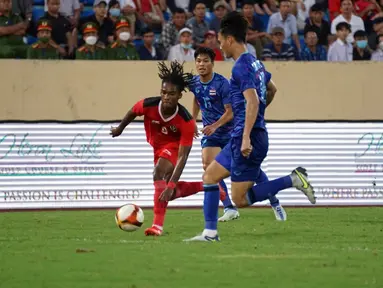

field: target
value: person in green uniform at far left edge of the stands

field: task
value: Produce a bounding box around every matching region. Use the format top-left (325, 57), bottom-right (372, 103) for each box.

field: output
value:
top-left (0, 0), bottom-right (28, 58)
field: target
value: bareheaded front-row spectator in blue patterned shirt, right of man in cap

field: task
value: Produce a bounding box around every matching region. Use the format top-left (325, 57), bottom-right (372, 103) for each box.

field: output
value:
top-left (300, 29), bottom-right (327, 61)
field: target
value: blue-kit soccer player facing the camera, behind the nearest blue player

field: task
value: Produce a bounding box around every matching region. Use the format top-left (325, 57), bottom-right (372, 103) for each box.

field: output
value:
top-left (190, 46), bottom-right (287, 222)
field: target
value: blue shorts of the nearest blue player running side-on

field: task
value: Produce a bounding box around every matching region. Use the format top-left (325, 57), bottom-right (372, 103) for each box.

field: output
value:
top-left (215, 129), bottom-right (269, 182)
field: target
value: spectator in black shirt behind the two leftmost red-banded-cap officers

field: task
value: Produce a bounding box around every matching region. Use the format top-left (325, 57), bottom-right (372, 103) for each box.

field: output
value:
top-left (43, 0), bottom-right (76, 58)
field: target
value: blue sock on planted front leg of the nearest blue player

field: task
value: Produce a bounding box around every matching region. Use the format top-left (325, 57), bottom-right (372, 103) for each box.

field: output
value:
top-left (203, 184), bottom-right (219, 230)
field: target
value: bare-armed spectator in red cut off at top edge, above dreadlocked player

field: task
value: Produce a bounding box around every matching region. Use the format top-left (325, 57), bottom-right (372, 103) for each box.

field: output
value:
top-left (137, 0), bottom-right (166, 29)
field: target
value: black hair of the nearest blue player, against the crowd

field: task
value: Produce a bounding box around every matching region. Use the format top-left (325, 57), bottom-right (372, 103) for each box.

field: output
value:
top-left (220, 11), bottom-right (248, 43)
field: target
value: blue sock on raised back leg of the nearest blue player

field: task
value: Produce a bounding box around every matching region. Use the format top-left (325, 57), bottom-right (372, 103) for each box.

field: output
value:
top-left (247, 176), bottom-right (293, 205)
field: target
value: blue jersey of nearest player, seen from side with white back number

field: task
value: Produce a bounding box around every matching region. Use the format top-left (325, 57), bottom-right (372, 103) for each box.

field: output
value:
top-left (230, 53), bottom-right (271, 137)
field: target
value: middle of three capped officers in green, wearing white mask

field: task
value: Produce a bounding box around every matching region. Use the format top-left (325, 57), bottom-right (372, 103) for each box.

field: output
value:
top-left (76, 22), bottom-right (106, 60)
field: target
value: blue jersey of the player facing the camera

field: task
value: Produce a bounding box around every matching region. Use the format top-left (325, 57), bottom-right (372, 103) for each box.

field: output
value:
top-left (190, 73), bottom-right (233, 138)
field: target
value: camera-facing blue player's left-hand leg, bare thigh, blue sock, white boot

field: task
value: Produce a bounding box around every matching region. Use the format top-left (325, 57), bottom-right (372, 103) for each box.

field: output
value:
top-left (202, 147), bottom-right (239, 222)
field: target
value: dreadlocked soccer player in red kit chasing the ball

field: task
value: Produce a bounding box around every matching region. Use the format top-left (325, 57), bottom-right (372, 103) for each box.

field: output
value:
top-left (110, 61), bottom-right (225, 236)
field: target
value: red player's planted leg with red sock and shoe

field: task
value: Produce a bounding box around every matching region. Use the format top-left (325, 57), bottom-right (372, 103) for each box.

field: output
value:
top-left (145, 158), bottom-right (174, 236)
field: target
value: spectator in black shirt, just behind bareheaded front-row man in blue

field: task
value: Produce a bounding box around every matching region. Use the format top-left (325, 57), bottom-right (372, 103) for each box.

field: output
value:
top-left (304, 4), bottom-right (330, 47)
